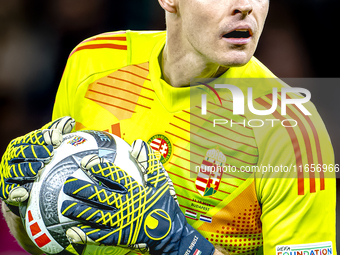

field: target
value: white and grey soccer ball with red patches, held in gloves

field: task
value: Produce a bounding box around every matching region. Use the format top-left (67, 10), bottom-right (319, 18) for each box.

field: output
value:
top-left (20, 131), bottom-right (143, 255)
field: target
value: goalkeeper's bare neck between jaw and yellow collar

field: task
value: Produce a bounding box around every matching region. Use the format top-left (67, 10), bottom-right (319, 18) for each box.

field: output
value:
top-left (161, 26), bottom-right (228, 87)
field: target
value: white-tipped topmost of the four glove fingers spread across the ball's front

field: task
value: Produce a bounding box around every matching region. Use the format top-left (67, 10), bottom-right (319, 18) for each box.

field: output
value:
top-left (80, 154), bottom-right (136, 189)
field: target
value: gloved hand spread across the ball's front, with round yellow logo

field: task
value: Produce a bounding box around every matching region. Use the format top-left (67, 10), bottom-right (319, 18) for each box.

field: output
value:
top-left (61, 140), bottom-right (214, 254)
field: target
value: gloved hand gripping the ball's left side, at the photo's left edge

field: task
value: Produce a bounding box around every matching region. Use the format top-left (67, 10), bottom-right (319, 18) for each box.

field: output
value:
top-left (0, 117), bottom-right (74, 209)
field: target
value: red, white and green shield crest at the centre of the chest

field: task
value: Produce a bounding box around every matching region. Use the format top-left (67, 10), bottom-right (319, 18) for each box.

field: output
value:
top-left (195, 149), bottom-right (227, 197)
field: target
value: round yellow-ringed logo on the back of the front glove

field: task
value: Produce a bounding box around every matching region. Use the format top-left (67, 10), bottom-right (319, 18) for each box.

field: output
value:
top-left (144, 209), bottom-right (171, 240)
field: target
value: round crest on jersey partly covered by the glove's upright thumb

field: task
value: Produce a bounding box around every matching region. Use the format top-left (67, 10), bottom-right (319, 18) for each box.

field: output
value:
top-left (148, 134), bottom-right (172, 164)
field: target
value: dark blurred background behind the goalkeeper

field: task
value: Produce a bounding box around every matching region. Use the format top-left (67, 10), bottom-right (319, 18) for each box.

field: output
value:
top-left (0, 0), bottom-right (340, 255)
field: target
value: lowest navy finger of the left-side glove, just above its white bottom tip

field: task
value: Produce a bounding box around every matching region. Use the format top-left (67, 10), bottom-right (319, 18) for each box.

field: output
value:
top-left (5, 162), bottom-right (44, 179)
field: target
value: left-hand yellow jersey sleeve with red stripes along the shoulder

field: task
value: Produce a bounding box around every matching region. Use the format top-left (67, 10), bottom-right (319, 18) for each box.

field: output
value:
top-left (52, 31), bottom-right (130, 125)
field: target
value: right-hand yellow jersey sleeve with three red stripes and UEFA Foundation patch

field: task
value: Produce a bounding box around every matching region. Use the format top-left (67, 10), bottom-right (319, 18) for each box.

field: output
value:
top-left (254, 96), bottom-right (337, 255)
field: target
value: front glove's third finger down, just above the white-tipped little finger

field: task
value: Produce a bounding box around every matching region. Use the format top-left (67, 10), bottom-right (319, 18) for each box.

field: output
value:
top-left (61, 200), bottom-right (117, 227)
